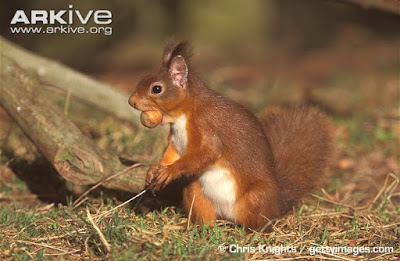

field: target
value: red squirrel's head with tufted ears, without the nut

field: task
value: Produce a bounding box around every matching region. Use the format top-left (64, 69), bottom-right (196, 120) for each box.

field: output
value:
top-left (129, 40), bottom-right (192, 124)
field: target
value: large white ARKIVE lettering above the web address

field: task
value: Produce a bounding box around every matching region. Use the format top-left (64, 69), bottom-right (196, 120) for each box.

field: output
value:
top-left (10, 5), bottom-right (112, 25)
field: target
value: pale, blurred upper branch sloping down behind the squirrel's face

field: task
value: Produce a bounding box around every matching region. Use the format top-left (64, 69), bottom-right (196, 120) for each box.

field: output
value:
top-left (0, 36), bottom-right (147, 126)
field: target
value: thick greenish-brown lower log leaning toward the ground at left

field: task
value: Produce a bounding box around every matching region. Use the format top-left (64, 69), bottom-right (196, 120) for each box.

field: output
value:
top-left (0, 55), bottom-right (145, 193)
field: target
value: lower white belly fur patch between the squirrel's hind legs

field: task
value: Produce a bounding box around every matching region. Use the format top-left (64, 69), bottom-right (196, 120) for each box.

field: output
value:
top-left (199, 166), bottom-right (236, 221)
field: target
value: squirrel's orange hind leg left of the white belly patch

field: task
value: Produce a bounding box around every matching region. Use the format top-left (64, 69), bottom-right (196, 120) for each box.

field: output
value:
top-left (183, 180), bottom-right (217, 226)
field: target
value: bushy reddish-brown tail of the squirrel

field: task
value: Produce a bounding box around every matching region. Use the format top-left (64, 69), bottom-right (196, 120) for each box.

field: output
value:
top-left (262, 106), bottom-right (333, 214)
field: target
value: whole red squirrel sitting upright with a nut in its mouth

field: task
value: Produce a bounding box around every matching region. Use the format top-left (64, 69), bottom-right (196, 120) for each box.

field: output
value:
top-left (129, 40), bottom-right (333, 229)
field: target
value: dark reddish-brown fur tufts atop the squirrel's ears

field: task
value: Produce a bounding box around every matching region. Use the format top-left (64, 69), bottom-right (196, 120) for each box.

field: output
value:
top-left (161, 38), bottom-right (193, 69)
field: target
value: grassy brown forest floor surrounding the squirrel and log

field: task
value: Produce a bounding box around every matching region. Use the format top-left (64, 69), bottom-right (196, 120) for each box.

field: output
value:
top-left (0, 27), bottom-right (400, 260)
